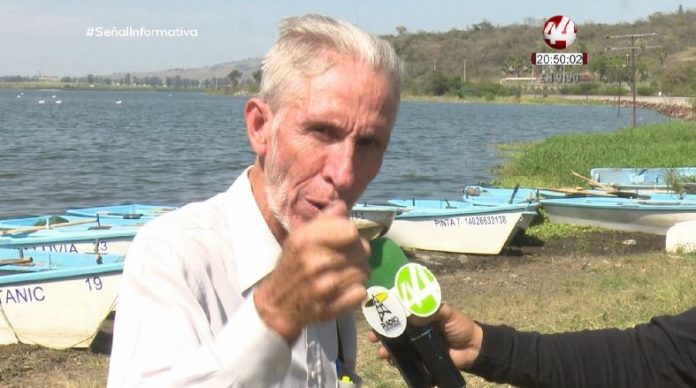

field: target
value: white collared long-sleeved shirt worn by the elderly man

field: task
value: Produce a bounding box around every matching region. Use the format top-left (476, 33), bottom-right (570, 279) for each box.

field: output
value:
top-left (108, 169), bottom-right (356, 387)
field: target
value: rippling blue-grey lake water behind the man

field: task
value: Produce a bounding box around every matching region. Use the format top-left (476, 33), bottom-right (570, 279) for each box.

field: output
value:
top-left (0, 90), bottom-right (668, 217)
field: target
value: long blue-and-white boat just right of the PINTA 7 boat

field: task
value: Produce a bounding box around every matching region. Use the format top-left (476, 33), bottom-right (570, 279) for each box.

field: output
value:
top-left (540, 194), bottom-right (696, 235)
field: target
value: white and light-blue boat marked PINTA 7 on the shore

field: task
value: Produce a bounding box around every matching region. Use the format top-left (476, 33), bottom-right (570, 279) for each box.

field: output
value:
top-left (385, 199), bottom-right (537, 255)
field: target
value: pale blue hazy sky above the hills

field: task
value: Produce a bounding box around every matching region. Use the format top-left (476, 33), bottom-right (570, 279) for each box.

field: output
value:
top-left (0, 0), bottom-right (696, 76)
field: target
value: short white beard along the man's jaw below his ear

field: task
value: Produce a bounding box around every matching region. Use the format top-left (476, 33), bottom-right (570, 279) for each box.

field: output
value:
top-left (263, 143), bottom-right (290, 232)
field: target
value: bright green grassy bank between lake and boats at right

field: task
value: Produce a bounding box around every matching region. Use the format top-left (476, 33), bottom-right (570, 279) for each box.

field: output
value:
top-left (494, 120), bottom-right (696, 187)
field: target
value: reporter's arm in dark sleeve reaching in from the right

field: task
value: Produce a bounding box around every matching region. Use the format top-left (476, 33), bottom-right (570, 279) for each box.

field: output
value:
top-left (467, 308), bottom-right (696, 387)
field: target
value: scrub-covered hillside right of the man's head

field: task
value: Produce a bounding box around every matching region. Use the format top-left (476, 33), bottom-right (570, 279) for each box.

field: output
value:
top-left (384, 9), bottom-right (696, 95)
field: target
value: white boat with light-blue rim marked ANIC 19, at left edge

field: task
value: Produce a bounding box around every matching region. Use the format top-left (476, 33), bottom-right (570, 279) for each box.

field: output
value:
top-left (0, 249), bottom-right (123, 348)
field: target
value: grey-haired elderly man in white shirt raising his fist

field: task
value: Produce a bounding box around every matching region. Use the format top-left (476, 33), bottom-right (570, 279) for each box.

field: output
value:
top-left (109, 15), bottom-right (401, 387)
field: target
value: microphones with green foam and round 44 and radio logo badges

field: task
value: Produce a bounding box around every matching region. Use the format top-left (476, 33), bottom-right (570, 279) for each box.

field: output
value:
top-left (362, 238), bottom-right (466, 388)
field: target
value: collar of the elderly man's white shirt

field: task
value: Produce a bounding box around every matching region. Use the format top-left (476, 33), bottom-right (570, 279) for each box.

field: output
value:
top-left (225, 167), bottom-right (281, 292)
